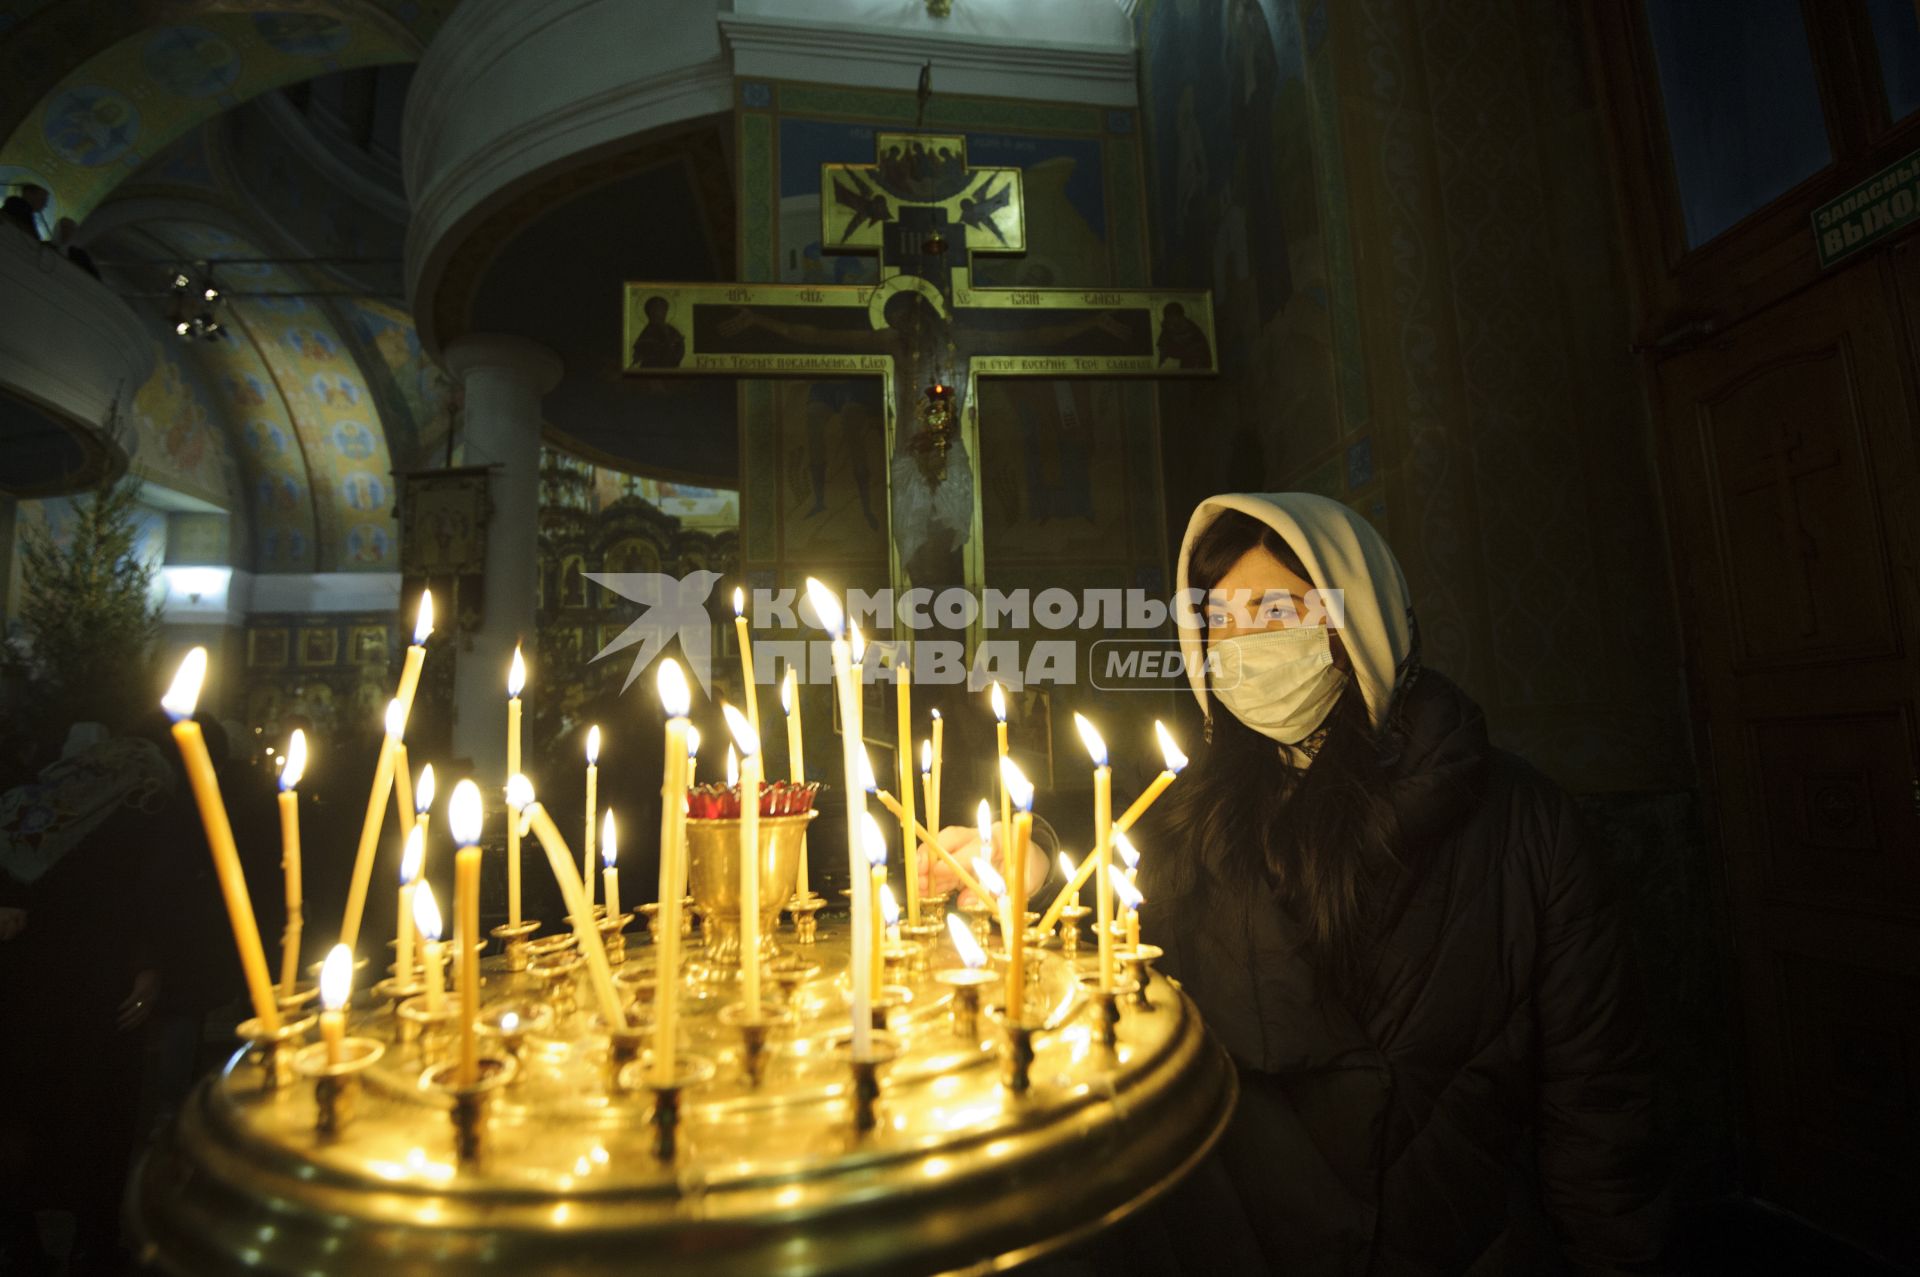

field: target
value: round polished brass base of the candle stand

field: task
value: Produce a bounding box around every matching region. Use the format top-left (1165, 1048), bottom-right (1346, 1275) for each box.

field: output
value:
top-left (129, 906), bottom-right (1235, 1277)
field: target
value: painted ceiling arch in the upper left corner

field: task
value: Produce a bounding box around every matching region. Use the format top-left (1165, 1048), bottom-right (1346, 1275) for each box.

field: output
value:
top-left (0, 0), bottom-right (453, 221)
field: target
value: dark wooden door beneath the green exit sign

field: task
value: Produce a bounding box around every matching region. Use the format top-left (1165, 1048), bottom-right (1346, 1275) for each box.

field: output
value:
top-left (1655, 253), bottom-right (1920, 1260)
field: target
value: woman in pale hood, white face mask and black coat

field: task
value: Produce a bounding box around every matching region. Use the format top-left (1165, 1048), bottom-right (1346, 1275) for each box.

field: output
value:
top-left (1104, 494), bottom-right (1667, 1277)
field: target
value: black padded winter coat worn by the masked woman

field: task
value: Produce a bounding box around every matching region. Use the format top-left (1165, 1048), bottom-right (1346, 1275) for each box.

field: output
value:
top-left (1121, 670), bottom-right (1668, 1277)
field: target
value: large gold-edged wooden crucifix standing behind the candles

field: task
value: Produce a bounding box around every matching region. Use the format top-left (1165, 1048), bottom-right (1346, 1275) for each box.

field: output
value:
top-left (626, 133), bottom-right (1217, 649)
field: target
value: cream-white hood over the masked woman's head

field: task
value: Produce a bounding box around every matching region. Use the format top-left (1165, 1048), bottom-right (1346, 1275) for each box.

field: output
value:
top-left (1175, 492), bottom-right (1413, 728)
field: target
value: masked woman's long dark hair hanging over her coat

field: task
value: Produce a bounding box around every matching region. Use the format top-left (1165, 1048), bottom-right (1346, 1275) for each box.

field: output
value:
top-left (1142, 511), bottom-right (1400, 1006)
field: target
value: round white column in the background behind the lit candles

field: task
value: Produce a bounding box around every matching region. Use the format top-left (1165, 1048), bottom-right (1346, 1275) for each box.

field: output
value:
top-left (442, 334), bottom-right (563, 775)
